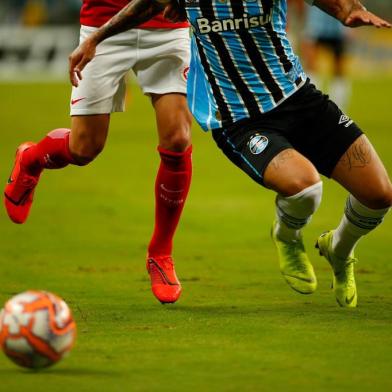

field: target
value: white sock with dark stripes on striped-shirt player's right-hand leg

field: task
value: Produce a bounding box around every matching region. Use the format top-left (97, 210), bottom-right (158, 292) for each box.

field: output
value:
top-left (332, 195), bottom-right (389, 260)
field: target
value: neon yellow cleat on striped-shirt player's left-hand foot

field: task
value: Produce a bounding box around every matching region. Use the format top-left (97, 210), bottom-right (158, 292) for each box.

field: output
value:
top-left (271, 221), bottom-right (317, 294)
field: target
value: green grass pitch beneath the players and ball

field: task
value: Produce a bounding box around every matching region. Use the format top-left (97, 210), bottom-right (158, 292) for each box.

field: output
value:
top-left (0, 79), bottom-right (392, 392)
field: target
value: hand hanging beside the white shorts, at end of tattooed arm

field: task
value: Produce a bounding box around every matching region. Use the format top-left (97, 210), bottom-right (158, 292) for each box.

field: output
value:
top-left (69, 37), bottom-right (97, 87)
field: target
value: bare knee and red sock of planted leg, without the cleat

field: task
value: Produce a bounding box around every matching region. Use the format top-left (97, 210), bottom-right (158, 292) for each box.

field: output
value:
top-left (148, 94), bottom-right (192, 257)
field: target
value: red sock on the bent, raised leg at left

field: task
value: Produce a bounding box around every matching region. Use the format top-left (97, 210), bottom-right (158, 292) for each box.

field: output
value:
top-left (23, 128), bottom-right (73, 174)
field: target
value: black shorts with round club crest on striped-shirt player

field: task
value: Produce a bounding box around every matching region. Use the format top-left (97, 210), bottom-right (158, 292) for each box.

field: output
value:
top-left (212, 81), bottom-right (362, 185)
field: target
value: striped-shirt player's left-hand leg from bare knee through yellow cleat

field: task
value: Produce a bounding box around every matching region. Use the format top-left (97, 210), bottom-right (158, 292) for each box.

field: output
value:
top-left (264, 149), bottom-right (322, 294)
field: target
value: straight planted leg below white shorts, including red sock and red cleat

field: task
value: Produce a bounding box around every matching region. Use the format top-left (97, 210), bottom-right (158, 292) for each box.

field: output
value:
top-left (147, 94), bottom-right (192, 303)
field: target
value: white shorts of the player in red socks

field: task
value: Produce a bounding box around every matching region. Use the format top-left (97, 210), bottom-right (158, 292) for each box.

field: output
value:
top-left (71, 26), bottom-right (190, 116)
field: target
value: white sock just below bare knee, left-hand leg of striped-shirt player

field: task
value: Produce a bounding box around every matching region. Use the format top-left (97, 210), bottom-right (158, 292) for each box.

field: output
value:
top-left (275, 181), bottom-right (323, 241)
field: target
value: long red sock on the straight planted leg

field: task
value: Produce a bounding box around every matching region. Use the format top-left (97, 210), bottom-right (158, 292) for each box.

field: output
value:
top-left (148, 146), bottom-right (192, 256)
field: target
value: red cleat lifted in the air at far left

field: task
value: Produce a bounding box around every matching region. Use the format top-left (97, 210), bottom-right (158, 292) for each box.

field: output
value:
top-left (4, 142), bottom-right (40, 223)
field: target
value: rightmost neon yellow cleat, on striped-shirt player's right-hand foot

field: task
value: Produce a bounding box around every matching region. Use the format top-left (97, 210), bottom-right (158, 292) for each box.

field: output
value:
top-left (316, 230), bottom-right (357, 308)
